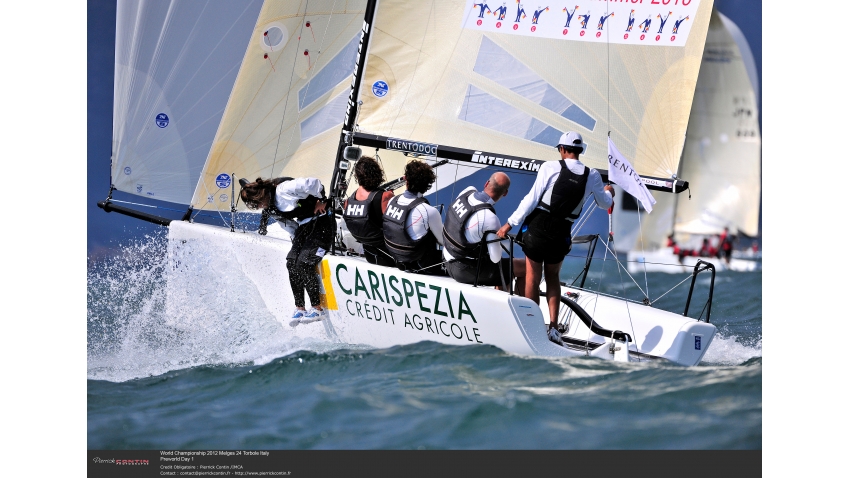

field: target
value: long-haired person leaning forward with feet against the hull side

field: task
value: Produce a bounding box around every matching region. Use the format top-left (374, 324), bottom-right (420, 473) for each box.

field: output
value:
top-left (239, 178), bottom-right (336, 327)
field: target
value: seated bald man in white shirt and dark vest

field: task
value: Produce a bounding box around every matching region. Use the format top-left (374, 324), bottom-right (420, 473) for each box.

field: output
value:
top-left (443, 172), bottom-right (525, 295)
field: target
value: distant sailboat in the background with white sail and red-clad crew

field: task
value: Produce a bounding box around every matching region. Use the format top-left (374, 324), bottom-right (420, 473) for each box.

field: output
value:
top-left (614, 9), bottom-right (761, 273)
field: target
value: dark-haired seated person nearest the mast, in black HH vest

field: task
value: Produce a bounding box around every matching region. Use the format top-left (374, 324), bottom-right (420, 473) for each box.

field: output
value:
top-left (342, 156), bottom-right (395, 267)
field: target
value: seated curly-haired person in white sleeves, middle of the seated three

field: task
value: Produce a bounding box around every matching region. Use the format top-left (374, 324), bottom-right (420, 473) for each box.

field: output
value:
top-left (384, 160), bottom-right (446, 275)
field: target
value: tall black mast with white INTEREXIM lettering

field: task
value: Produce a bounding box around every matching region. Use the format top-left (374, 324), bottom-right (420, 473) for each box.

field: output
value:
top-left (329, 0), bottom-right (378, 211)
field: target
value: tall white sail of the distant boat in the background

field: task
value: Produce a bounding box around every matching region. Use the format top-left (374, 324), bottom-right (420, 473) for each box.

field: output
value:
top-left (675, 7), bottom-right (761, 239)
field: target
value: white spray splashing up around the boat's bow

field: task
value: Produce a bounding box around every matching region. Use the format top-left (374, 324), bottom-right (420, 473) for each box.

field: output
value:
top-left (88, 236), bottom-right (342, 382)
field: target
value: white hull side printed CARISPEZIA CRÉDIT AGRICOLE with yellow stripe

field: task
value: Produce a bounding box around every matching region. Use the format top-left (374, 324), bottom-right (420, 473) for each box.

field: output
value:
top-left (320, 256), bottom-right (545, 353)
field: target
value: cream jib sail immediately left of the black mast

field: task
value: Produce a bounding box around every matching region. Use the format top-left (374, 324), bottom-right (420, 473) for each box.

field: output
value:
top-left (192, 0), bottom-right (366, 211)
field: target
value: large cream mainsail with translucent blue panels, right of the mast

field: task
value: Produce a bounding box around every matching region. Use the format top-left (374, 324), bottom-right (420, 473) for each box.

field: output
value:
top-left (359, 0), bottom-right (712, 178)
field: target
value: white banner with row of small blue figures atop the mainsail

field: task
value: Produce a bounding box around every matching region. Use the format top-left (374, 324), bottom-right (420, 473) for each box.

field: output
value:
top-left (461, 0), bottom-right (700, 46)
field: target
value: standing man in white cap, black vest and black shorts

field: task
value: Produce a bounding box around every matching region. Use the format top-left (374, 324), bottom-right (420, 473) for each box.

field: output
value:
top-left (496, 131), bottom-right (614, 344)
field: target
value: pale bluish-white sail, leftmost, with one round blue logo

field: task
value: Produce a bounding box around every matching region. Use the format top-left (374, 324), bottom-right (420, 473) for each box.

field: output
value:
top-left (111, 0), bottom-right (262, 204)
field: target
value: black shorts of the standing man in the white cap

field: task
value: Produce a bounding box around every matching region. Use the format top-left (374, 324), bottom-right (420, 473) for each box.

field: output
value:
top-left (517, 209), bottom-right (572, 264)
